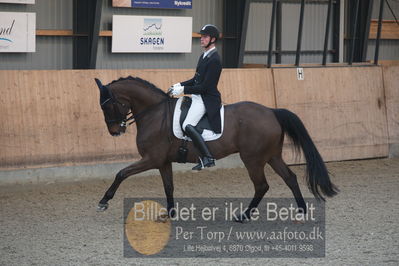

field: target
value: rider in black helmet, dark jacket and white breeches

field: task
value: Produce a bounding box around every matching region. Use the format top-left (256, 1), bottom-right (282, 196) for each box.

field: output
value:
top-left (170, 24), bottom-right (222, 170)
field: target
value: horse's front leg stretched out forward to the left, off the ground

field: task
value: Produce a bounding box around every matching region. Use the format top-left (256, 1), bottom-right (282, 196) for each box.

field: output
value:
top-left (97, 158), bottom-right (154, 211)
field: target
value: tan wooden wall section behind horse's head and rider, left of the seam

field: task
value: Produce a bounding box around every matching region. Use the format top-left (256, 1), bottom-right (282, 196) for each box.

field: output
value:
top-left (0, 69), bottom-right (275, 169)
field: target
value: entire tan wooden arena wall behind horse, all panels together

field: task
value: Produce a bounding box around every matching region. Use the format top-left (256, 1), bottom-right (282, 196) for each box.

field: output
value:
top-left (0, 66), bottom-right (399, 170)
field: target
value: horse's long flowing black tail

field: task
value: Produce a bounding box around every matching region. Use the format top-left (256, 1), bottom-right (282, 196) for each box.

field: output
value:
top-left (273, 109), bottom-right (338, 200)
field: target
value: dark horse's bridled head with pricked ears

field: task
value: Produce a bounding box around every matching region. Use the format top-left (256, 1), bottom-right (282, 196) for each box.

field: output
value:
top-left (95, 79), bottom-right (130, 136)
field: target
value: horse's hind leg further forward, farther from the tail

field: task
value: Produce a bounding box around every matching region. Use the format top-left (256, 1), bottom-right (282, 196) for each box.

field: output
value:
top-left (237, 156), bottom-right (269, 222)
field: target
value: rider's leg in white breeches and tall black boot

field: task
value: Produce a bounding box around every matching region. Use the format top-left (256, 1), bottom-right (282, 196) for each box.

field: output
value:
top-left (183, 95), bottom-right (215, 170)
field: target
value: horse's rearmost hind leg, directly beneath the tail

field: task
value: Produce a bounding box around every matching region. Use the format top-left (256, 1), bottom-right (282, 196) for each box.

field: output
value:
top-left (268, 156), bottom-right (306, 213)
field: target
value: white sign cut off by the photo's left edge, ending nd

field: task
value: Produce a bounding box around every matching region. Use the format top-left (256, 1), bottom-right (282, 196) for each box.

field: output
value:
top-left (0, 12), bottom-right (36, 53)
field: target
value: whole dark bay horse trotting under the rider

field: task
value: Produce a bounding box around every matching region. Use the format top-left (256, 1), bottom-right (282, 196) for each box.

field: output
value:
top-left (96, 77), bottom-right (338, 219)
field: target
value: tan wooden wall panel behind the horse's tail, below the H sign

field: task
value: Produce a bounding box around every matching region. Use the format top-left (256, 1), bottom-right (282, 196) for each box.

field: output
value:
top-left (274, 67), bottom-right (388, 161)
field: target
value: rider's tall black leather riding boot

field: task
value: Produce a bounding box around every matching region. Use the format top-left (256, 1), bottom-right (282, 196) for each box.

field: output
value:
top-left (186, 125), bottom-right (215, 171)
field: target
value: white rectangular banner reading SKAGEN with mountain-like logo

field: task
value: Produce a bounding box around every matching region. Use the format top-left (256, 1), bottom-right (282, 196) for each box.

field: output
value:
top-left (112, 15), bottom-right (193, 53)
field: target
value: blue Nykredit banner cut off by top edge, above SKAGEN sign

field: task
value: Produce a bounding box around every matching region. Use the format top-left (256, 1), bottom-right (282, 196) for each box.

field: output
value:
top-left (112, 0), bottom-right (193, 9)
